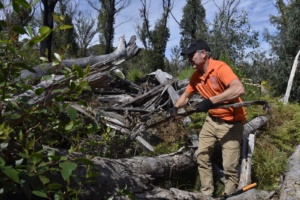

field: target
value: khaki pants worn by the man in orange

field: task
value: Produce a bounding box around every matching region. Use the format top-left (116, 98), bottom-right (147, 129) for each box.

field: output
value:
top-left (197, 116), bottom-right (244, 195)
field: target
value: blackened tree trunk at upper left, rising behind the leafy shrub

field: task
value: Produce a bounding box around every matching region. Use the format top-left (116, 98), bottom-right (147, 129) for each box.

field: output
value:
top-left (40, 0), bottom-right (58, 62)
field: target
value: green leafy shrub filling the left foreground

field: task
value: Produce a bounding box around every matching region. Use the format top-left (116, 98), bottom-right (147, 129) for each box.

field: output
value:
top-left (0, 0), bottom-right (98, 199)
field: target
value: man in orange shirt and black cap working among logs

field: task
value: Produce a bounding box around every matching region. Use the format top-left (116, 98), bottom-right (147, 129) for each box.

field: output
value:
top-left (166, 40), bottom-right (246, 196)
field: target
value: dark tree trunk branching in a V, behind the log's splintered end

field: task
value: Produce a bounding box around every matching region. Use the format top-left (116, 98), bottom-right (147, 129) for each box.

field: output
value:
top-left (87, 0), bottom-right (130, 54)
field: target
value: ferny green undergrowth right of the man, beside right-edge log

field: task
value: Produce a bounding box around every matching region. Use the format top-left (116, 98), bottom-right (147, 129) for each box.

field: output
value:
top-left (253, 101), bottom-right (300, 190)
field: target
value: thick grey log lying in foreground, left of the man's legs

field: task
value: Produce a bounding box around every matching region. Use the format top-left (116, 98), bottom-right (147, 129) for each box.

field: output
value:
top-left (45, 147), bottom-right (195, 199)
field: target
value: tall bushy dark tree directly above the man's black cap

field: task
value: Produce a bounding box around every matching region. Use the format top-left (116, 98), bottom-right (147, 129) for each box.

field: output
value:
top-left (180, 0), bottom-right (207, 48)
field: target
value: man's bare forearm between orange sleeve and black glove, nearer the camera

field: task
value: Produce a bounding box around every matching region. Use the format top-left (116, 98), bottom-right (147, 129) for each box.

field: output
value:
top-left (209, 79), bottom-right (245, 104)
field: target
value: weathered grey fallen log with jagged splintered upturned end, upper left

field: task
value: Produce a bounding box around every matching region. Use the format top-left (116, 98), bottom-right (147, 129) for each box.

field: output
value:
top-left (9, 36), bottom-right (140, 126)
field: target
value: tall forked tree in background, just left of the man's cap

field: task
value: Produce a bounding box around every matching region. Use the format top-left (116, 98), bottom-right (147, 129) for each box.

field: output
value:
top-left (137, 0), bottom-right (172, 70)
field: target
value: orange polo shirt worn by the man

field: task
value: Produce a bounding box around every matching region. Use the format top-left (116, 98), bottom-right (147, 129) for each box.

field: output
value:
top-left (186, 58), bottom-right (246, 123)
